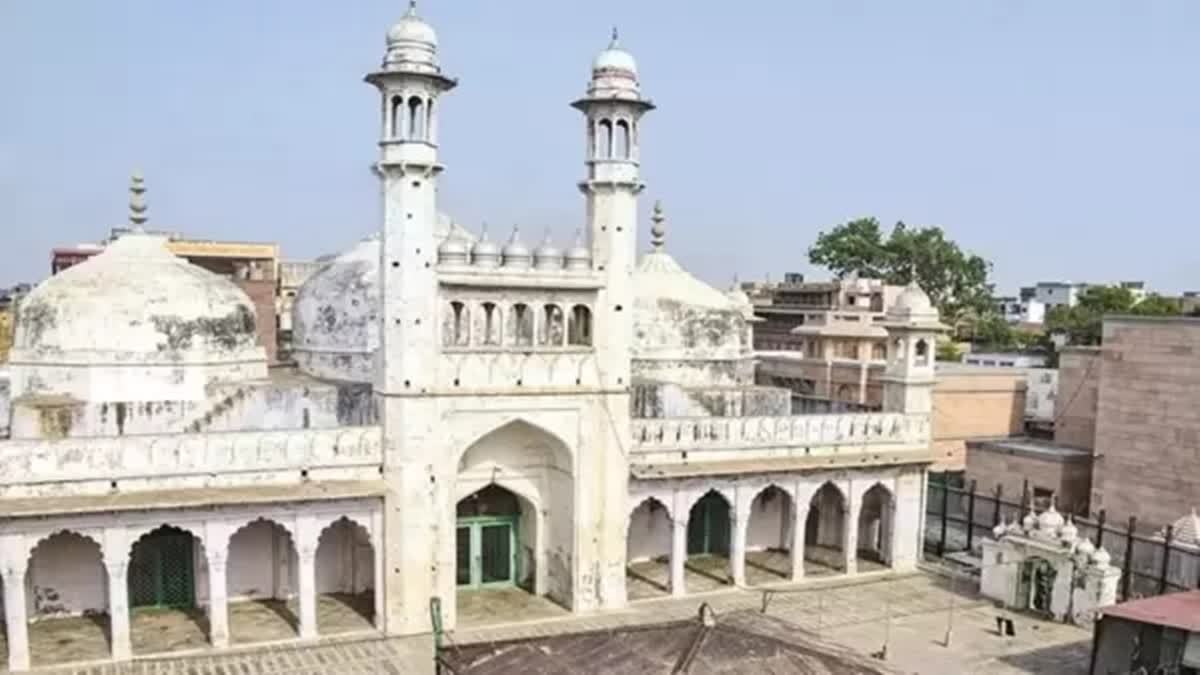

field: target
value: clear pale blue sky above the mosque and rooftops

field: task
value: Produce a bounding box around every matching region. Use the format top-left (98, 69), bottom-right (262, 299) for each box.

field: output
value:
top-left (0, 0), bottom-right (1200, 292)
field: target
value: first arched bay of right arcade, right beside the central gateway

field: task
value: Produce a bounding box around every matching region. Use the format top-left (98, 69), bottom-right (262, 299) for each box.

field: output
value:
top-left (625, 497), bottom-right (672, 601)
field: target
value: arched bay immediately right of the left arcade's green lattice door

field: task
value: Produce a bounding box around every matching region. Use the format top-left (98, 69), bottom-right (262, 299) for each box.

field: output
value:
top-left (226, 519), bottom-right (300, 644)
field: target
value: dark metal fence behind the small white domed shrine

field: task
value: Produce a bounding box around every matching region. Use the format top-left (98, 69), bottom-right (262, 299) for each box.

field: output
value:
top-left (925, 480), bottom-right (1200, 601)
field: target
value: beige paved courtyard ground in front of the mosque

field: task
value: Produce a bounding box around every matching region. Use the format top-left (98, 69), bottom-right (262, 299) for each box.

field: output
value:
top-left (2, 573), bottom-right (1090, 675)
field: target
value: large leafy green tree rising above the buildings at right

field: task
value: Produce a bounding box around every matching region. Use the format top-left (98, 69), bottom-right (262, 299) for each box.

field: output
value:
top-left (809, 217), bottom-right (994, 324)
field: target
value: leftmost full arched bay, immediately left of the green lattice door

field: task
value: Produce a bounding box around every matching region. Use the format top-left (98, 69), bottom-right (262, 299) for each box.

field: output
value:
top-left (25, 531), bottom-right (112, 665)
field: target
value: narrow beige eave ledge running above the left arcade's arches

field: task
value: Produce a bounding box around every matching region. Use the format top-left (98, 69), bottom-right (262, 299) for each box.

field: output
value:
top-left (0, 480), bottom-right (388, 518)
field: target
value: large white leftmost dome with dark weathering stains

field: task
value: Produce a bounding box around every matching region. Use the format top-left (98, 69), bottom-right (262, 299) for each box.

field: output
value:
top-left (11, 232), bottom-right (266, 365)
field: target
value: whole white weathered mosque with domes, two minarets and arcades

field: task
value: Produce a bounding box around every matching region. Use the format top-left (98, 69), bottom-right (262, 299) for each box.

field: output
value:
top-left (0, 3), bottom-right (943, 671)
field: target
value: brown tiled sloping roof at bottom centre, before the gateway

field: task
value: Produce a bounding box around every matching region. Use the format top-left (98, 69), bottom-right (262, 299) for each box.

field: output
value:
top-left (440, 611), bottom-right (896, 675)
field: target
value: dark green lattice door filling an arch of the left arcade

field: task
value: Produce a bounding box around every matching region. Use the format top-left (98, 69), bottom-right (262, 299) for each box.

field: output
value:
top-left (128, 527), bottom-right (196, 608)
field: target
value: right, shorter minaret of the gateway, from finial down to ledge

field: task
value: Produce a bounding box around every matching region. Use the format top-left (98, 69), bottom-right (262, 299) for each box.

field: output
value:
top-left (572, 29), bottom-right (654, 389)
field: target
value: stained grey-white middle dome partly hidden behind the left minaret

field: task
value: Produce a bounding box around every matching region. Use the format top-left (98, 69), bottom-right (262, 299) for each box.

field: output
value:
top-left (292, 235), bottom-right (383, 382)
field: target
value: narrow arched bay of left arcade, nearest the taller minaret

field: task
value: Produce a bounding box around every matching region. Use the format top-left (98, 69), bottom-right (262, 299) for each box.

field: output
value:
top-left (316, 518), bottom-right (376, 635)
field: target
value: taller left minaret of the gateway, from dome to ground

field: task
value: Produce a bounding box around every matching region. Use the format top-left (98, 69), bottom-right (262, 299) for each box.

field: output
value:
top-left (366, 1), bottom-right (456, 635)
